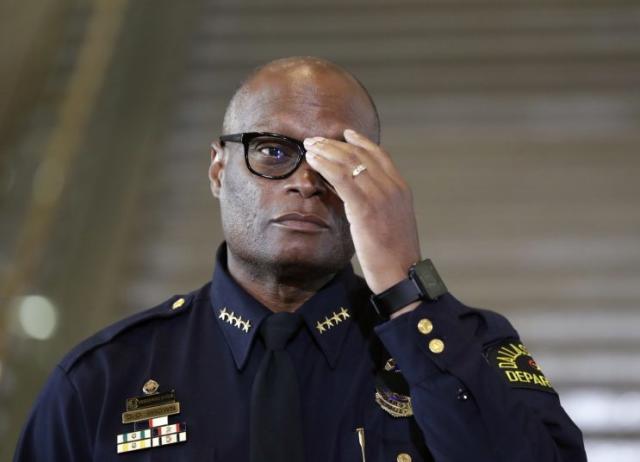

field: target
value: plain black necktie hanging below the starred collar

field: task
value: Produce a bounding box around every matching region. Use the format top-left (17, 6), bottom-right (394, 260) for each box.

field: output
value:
top-left (249, 313), bottom-right (304, 462)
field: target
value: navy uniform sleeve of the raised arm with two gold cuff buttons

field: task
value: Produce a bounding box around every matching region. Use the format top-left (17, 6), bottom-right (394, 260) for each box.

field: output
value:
top-left (376, 294), bottom-right (586, 462)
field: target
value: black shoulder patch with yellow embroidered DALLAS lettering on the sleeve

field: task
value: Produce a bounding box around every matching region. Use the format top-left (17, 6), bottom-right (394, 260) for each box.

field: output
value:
top-left (487, 340), bottom-right (556, 393)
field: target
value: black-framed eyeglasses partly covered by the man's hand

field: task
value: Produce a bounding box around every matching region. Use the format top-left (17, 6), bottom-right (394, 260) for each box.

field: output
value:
top-left (220, 132), bottom-right (307, 180)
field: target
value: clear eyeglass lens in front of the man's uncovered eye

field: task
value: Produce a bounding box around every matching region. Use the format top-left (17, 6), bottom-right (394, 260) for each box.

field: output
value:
top-left (247, 136), bottom-right (302, 176)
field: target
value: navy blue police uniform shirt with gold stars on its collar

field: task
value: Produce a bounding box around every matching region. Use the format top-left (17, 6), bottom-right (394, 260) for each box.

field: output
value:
top-left (14, 245), bottom-right (586, 462)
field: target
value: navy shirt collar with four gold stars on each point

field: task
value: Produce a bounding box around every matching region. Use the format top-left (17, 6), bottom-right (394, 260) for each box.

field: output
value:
top-left (210, 243), bottom-right (357, 370)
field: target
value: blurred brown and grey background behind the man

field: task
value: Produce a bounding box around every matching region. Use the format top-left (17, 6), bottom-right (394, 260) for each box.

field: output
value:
top-left (0, 0), bottom-right (640, 462)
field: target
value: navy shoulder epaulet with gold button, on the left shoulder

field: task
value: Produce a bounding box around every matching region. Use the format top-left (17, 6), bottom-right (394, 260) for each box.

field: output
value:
top-left (59, 292), bottom-right (196, 372)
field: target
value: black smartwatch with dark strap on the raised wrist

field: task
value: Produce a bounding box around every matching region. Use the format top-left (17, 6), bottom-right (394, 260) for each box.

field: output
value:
top-left (371, 258), bottom-right (448, 319)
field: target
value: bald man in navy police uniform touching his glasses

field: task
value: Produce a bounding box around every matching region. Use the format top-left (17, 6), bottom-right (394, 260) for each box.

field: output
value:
top-left (15, 58), bottom-right (586, 462)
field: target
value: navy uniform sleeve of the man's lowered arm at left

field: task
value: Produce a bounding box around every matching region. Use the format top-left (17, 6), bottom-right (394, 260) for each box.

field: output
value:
top-left (13, 367), bottom-right (92, 462)
